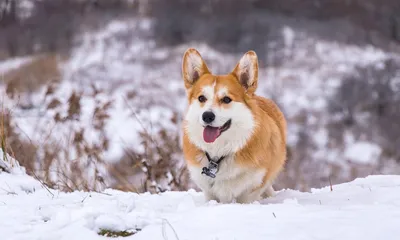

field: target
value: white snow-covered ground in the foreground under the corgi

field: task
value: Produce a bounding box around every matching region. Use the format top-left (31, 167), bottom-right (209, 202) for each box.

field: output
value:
top-left (0, 152), bottom-right (400, 240)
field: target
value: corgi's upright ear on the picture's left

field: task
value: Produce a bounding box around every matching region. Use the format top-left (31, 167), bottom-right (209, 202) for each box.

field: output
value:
top-left (182, 48), bottom-right (210, 89)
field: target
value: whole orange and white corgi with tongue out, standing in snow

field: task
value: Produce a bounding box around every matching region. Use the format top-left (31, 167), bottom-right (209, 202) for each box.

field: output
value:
top-left (182, 48), bottom-right (286, 203)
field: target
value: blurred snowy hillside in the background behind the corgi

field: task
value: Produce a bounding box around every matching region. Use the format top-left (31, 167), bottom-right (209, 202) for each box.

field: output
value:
top-left (0, 18), bottom-right (399, 192)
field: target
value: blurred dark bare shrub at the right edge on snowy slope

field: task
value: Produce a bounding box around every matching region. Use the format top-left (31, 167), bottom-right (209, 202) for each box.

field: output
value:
top-left (328, 59), bottom-right (400, 161)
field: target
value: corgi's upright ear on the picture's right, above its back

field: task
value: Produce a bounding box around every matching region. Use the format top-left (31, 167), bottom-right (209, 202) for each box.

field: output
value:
top-left (232, 51), bottom-right (258, 94)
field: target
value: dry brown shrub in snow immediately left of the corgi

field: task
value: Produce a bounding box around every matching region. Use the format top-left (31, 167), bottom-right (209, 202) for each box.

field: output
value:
top-left (109, 124), bottom-right (189, 193)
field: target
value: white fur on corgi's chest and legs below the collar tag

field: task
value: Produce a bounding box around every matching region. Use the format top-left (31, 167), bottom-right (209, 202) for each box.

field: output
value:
top-left (188, 156), bottom-right (265, 203)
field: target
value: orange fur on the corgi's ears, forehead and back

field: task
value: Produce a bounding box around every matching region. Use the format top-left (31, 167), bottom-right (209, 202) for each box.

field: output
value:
top-left (183, 49), bottom-right (286, 202)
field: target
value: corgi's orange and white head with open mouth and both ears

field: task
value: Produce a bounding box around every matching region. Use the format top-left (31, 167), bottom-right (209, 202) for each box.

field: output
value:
top-left (182, 48), bottom-right (258, 151)
